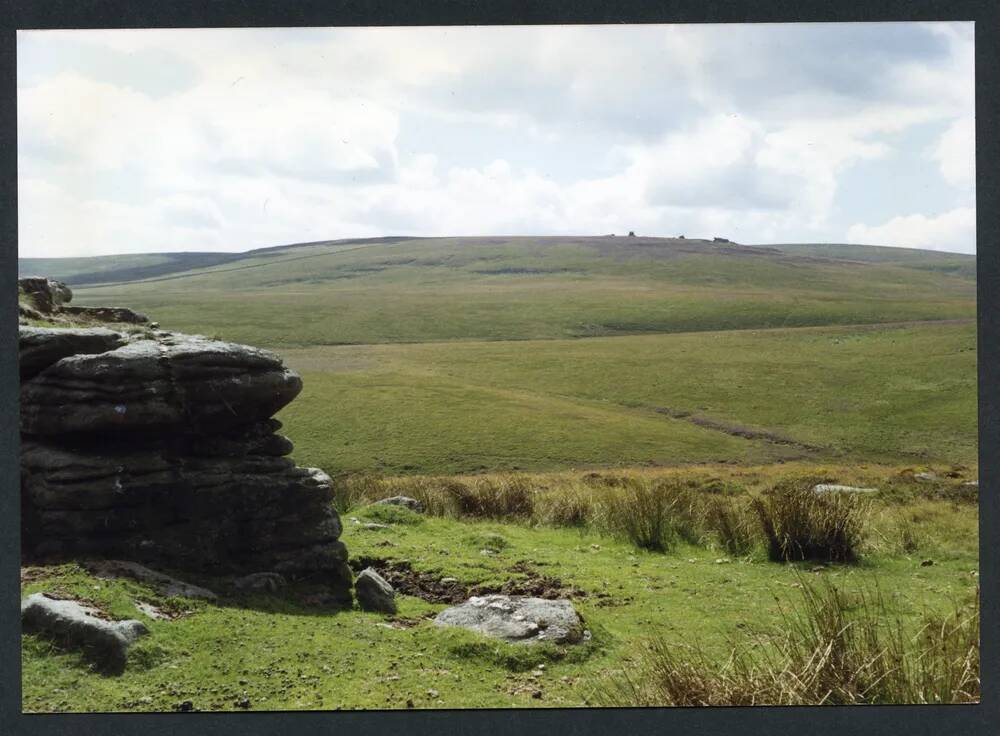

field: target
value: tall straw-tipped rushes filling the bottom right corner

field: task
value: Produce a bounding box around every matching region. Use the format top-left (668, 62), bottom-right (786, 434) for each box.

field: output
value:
top-left (599, 583), bottom-right (980, 706)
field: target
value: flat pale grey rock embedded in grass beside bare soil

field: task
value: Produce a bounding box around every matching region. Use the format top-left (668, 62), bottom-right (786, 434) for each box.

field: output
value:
top-left (434, 594), bottom-right (589, 644)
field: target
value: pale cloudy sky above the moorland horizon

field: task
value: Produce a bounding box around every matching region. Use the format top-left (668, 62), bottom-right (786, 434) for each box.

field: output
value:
top-left (17, 23), bottom-right (976, 257)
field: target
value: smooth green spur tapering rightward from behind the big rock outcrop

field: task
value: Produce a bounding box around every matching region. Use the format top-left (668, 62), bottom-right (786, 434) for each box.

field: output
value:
top-left (279, 366), bottom-right (788, 473)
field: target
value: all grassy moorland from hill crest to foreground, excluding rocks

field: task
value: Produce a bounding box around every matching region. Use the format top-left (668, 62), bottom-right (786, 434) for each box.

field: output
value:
top-left (20, 236), bottom-right (979, 711)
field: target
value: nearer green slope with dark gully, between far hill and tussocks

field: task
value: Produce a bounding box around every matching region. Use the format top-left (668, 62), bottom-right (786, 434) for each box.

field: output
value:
top-left (280, 324), bottom-right (977, 474)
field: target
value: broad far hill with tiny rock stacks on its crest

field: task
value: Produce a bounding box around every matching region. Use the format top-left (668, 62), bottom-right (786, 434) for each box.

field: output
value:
top-left (70, 238), bottom-right (975, 349)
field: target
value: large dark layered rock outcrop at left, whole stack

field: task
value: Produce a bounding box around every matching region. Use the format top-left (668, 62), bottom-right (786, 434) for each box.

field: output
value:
top-left (20, 327), bottom-right (351, 602)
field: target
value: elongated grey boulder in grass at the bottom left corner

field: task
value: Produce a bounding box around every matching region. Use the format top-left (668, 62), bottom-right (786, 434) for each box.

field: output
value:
top-left (21, 593), bottom-right (149, 674)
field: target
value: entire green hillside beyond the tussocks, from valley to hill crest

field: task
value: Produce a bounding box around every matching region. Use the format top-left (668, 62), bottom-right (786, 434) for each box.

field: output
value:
top-left (56, 238), bottom-right (975, 473)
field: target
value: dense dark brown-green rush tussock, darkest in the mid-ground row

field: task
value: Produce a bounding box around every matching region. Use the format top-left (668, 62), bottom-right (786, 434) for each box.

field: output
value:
top-left (751, 480), bottom-right (871, 562)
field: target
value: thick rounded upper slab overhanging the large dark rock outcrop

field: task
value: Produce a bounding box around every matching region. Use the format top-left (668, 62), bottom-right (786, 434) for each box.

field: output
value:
top-left (21, 330), bottom-right (302, 442)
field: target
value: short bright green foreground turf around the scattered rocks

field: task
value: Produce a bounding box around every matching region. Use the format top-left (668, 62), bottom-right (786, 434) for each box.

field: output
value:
top-left (22, 468), bottom-right (978, 711)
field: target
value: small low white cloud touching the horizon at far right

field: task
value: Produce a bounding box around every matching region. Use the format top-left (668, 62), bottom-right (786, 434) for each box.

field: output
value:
top-left (847, 207), bottom-right (976, 253)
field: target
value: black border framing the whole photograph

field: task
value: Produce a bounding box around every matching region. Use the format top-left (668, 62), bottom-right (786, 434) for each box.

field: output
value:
top-left (0, 0), bottom-right (1000, 736)
